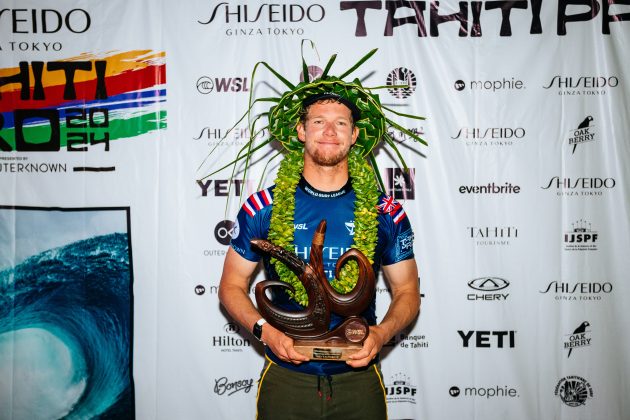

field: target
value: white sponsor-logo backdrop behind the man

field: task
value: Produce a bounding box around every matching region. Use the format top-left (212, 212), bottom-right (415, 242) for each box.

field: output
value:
top-left (0, 0), bottom-right (630, 420)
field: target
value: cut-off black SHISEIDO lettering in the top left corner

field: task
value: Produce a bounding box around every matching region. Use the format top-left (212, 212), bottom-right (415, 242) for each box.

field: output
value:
top-left (0, 7), bottom-right (92, 34)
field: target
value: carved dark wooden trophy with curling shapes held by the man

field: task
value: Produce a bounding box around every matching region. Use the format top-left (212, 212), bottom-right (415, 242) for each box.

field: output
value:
top-left (251, 220), bottom-right (375, 361)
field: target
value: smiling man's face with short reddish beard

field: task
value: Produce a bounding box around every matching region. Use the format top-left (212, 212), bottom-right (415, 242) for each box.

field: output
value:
top-left (297, 101), bottom-right (359, 166)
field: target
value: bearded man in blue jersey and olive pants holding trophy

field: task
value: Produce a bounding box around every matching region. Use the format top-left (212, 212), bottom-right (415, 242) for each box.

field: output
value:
top-left (219, 93), bottom-right (420, 419)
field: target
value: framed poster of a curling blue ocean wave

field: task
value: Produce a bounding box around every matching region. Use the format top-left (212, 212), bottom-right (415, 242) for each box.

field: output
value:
top-left (0, 206), bottom-right (135, 420)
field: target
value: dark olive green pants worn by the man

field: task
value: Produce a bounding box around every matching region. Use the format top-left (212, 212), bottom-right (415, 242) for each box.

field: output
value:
top-left (256, 360), bottom-right (387, 420)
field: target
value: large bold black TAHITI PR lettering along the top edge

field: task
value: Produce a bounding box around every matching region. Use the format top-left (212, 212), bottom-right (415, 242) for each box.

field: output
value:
top-left (340, 0), bottom-right (628, 38)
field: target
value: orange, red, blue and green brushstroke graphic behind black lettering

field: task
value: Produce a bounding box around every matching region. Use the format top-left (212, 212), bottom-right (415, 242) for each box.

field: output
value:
top-left (0, 50), bottom-right (166, 151)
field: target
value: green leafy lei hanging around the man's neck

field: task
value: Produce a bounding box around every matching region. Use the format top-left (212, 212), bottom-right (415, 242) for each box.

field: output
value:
top-left (269, 148), bottom-right (379, 306)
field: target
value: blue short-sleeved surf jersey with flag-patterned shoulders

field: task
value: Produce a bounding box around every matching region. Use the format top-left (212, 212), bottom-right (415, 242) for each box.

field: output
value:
top-left (231, 178), bottom-right (414, 375)
